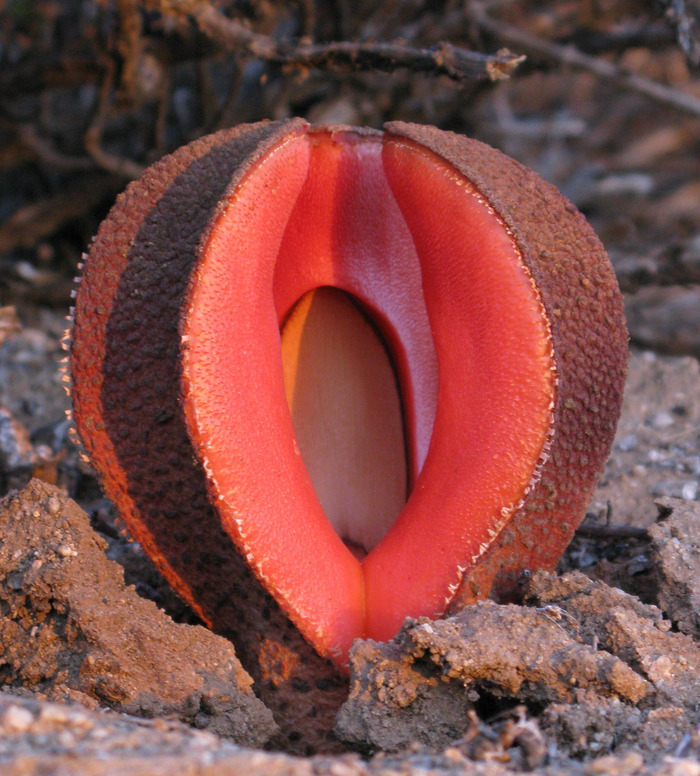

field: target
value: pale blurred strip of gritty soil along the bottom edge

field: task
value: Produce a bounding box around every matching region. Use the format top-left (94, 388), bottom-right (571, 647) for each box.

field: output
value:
top-left (0, 693), bottom-right (700, 776)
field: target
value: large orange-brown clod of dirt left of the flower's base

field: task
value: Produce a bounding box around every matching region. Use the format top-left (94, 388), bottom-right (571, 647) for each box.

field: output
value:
top-left (0, 480), bottom-right (276, 746)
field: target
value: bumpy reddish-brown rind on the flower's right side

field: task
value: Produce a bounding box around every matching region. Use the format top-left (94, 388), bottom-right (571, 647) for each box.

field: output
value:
top-left (385, 122), bottom-right (628, 610)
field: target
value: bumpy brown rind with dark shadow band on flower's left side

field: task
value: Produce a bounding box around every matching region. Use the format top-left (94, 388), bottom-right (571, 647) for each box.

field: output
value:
top-left (71, 120), bottom-right (347, 753)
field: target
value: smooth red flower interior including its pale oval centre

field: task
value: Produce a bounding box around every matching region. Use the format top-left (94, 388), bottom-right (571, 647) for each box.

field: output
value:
top-left (182, 130), bottom-right (556, 663)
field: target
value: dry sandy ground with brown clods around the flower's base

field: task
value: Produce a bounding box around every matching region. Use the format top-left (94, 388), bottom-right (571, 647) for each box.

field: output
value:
top-left (0, 316), bottom-right (700, 776)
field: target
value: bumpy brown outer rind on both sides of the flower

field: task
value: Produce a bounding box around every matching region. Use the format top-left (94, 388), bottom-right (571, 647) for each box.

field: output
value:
top-left (72, 120), bottom-right (627, 740)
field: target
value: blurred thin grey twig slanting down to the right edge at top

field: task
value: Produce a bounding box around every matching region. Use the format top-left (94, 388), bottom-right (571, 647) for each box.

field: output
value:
top-left (469, 2), bottom-right (700, 116)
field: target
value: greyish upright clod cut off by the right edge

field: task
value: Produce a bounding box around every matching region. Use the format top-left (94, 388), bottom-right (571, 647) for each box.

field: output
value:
top-left (649, 498), bottom-right (700, 639)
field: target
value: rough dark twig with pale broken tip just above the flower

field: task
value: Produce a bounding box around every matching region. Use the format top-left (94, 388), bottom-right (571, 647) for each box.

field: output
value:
top-left (145, 0), bottom-right (524, 81)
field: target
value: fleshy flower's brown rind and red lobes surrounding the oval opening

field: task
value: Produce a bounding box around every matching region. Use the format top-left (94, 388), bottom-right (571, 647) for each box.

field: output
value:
top-left (71, 119), bottom-right (627, 683)
